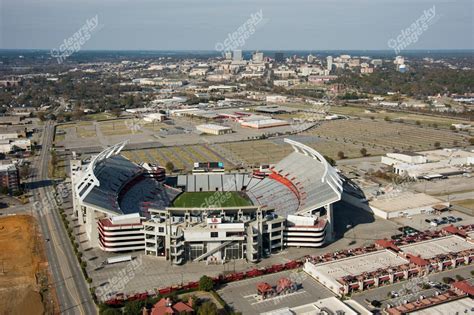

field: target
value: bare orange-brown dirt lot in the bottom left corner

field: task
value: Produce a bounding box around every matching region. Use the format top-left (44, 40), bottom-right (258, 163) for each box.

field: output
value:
top-left (0, 215), bottom-right (57, 315)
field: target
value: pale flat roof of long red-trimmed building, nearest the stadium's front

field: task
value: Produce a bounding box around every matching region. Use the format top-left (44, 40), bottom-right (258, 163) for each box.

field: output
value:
top-left (315, 250), bottom-right (408, 280)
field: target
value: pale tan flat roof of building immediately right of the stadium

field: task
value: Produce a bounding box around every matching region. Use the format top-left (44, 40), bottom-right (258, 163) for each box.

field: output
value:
top-left (370, 192), bottom-right (443, 212)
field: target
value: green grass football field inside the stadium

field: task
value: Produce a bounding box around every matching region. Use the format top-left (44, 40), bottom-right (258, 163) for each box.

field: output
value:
top-left (173, 191), bottom-right (252, 208)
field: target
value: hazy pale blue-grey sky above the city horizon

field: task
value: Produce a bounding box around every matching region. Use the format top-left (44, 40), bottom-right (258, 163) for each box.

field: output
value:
top-left (0, 0), bottom-right (474, 50)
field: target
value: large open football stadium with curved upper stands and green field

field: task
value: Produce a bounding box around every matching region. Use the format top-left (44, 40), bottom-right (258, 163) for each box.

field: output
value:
top-left (70, 139), bottom-right (342, 264)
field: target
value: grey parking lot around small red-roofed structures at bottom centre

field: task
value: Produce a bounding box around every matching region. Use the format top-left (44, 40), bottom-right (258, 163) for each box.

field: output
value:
top-left (218, 271), bottom-right (334, 314)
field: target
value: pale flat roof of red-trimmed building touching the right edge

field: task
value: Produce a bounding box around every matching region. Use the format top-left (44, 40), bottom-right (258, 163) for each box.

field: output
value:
top-left (400, 235), bottom-right (474, 259)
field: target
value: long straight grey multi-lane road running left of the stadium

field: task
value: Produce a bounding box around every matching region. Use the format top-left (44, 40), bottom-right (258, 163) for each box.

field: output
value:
top-left (31, 122), bottom-right (97, 315)
